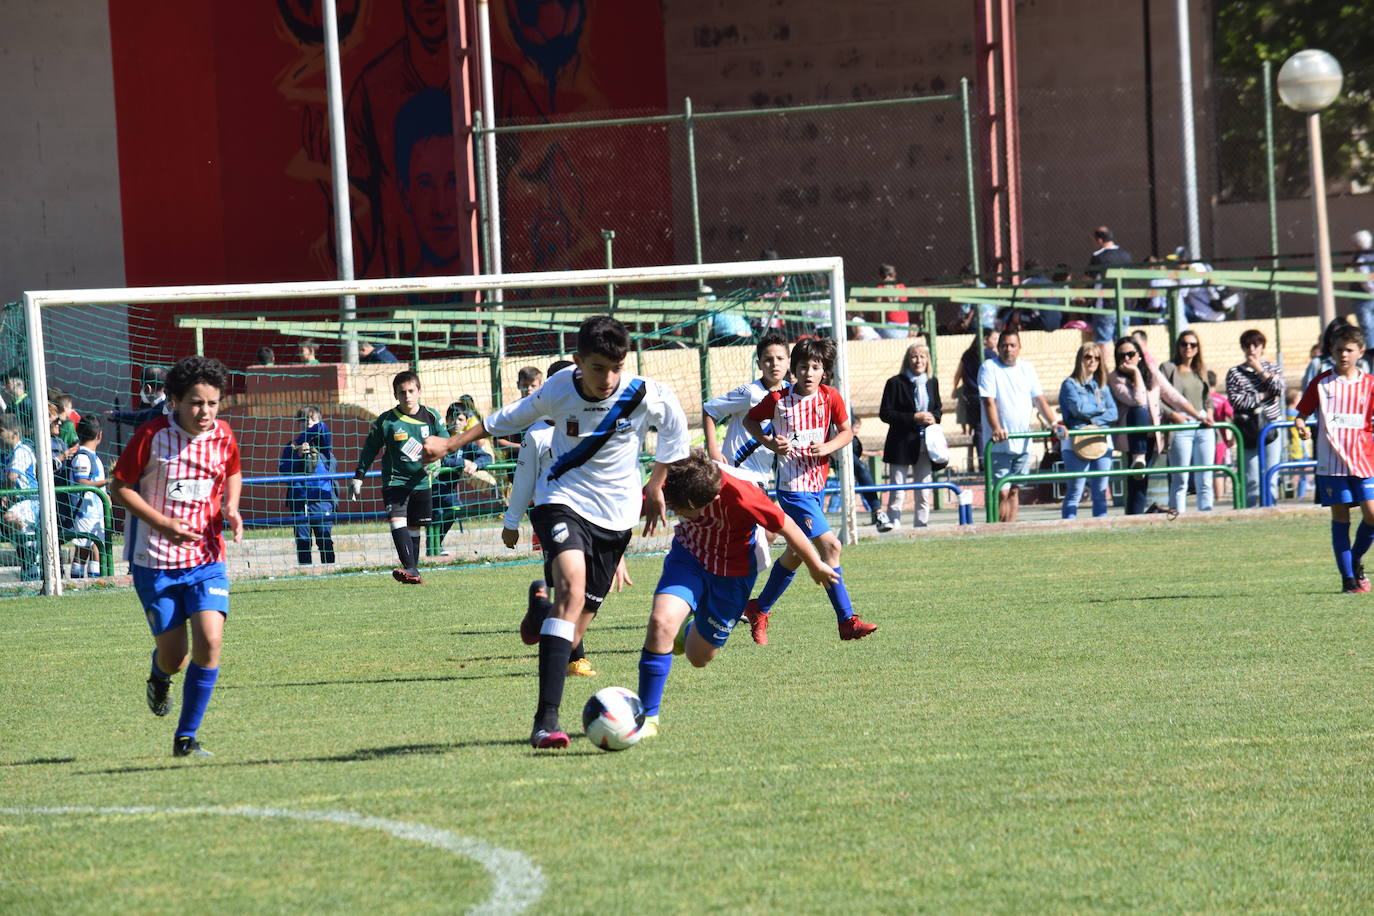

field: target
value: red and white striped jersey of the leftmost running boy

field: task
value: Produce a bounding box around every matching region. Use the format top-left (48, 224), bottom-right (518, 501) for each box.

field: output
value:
top-left (114, 416), bottom-right (239, 570)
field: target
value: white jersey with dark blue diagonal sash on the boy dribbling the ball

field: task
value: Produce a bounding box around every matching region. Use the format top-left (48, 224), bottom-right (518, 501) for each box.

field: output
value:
top-left (484, 368), bottom-right (691, 531)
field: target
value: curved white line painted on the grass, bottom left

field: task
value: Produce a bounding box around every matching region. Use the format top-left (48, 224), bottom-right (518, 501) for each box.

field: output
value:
top-left (0, 805), bottom-right (548, 916)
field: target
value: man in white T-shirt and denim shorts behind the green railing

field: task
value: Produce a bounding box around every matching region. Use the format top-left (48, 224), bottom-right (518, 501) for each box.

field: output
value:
top-left (978, 331), bottom-right (1062, 522)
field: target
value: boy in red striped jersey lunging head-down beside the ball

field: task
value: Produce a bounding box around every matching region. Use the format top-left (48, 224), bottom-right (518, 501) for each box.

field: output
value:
top-left (639, 449), bottom-right (840, 737)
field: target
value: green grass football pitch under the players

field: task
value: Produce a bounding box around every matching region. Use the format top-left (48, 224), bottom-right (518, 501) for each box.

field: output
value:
top-left (0, 514), bottom-right (1374, 913)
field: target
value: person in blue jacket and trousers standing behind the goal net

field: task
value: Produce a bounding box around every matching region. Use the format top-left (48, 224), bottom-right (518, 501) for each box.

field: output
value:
top-left (276, 404), bottom-right (338, 566)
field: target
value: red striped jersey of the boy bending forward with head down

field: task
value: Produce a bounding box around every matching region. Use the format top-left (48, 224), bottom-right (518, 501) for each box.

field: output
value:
top-left (673, 464), bottom-right (787, 577)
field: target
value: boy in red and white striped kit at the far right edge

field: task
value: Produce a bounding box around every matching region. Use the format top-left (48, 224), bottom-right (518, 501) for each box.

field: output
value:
top-left (1294, 325), bottom-right (1374, 595)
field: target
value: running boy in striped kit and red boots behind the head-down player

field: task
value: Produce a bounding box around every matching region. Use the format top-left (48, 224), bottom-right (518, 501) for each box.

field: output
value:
top-left (745, 338), bottom-right (878, 645)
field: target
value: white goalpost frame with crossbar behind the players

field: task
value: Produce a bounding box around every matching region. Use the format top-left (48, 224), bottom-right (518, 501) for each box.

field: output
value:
top-left (23, 257), bottom-right (856, 595)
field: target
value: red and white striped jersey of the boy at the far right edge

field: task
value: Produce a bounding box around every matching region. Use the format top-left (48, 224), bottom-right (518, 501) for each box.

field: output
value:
top-left (1297, 369), bottom-right (1374, 478)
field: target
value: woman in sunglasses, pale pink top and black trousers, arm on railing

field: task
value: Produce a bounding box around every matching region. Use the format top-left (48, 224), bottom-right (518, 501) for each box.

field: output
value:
top-left (1107, 336), bottom-right (1209, 515)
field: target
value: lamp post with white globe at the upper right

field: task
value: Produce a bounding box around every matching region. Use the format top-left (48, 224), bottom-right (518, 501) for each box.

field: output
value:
top-left (1278, 48), bottom-right (1342, 328)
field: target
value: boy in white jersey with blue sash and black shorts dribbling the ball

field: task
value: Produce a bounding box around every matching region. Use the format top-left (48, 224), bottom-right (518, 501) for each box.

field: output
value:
top-left (425, 316), bottom-right (688, 748)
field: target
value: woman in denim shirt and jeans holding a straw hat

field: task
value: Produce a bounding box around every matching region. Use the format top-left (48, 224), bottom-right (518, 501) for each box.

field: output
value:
top-left (1059, 343), bottom-right (1117, 519)
